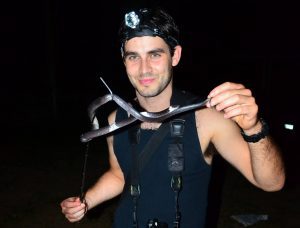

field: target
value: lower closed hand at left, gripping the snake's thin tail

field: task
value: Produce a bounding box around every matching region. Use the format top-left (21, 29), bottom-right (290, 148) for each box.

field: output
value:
top-left (60, 197), bottom-right (87, 222)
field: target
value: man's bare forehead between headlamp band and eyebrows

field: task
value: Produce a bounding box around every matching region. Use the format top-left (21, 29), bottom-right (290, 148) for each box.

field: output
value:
top-left (125, 36), bottom-right (168, 52)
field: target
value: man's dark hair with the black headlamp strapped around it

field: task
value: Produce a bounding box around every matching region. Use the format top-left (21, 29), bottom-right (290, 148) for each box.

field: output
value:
top-left (119, 8), bottom-right (179, 55)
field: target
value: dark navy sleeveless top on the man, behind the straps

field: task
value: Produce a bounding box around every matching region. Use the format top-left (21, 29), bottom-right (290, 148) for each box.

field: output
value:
top-left (113, 89), bottom-right (211, 228)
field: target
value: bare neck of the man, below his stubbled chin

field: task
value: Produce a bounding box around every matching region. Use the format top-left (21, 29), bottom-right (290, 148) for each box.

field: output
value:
top-left (136, 83), bottom-right (172, 112)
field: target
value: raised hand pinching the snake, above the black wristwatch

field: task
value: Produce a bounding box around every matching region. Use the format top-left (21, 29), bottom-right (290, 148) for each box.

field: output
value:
top-left (207, 82), bottom-right (258, 130)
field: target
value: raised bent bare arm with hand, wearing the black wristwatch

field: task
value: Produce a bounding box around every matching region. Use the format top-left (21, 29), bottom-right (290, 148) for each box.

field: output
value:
top-left (205, 83), bottom-right (285, 191)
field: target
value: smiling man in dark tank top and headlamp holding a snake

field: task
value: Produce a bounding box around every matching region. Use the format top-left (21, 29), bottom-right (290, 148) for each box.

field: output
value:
top-left (61, 9), bottom-right (285, 228)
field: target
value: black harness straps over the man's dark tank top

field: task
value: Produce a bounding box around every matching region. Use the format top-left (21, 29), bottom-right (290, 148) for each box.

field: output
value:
top-left (129, 119), bottom-right (185, 228)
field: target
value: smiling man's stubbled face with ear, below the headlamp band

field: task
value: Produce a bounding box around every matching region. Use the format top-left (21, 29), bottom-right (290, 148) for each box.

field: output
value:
top-left (124, 36), bottom-right (181, 97)
